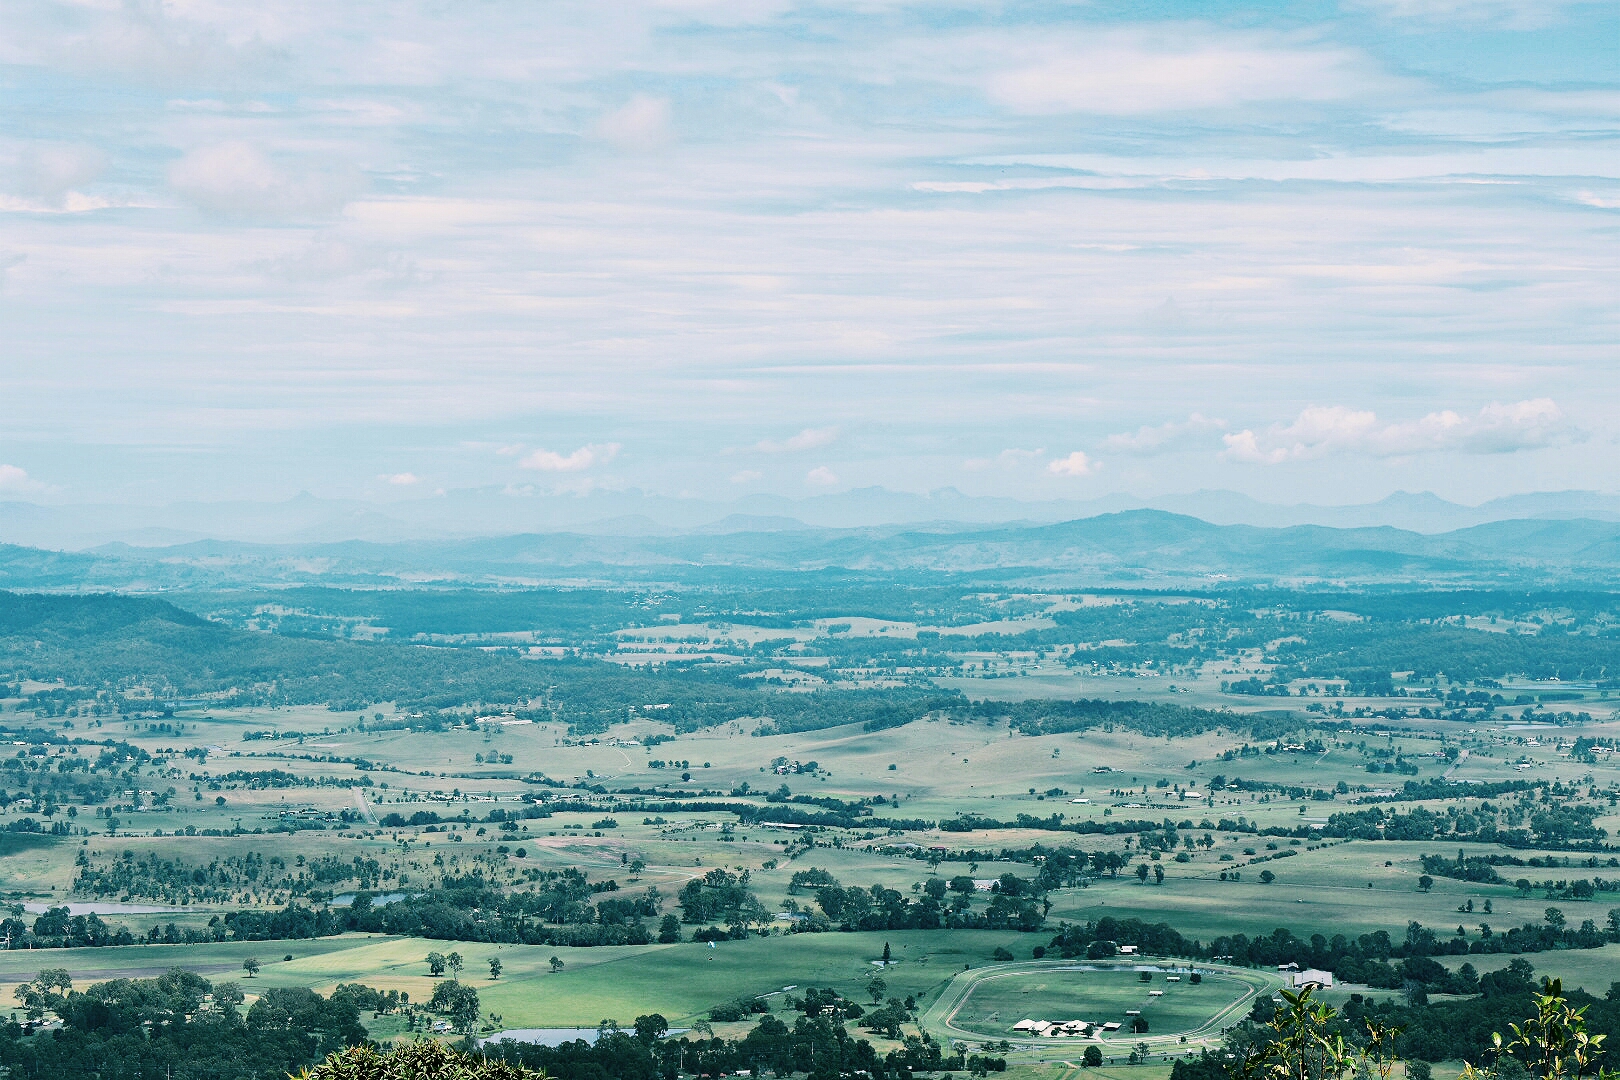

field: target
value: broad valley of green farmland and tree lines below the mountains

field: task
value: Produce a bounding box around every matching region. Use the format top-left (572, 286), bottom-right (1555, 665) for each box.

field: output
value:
top-left (0, 591), bottom-right (1620, 1067)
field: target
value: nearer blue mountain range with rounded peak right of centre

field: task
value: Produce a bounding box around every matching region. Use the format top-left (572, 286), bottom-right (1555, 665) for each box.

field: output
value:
top-left (9, 510), bottom-right (1620, 591)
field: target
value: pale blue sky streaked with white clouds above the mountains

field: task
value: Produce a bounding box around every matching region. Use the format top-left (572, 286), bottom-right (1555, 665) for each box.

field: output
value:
top-left (0, 0), bottom-right (1620, 514)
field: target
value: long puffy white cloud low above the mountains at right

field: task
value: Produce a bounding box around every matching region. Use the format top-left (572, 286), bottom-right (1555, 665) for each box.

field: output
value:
top-left (1221, 398), bottom-right (1584, 465)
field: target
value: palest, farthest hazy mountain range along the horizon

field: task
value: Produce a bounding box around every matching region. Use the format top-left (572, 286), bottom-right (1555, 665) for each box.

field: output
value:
top-left (0, 487), bottom-right (1620, 551)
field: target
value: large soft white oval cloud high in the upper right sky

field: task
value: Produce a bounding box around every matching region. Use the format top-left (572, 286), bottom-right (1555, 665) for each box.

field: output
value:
top-left (987, 31), bottom-right (1387, 115)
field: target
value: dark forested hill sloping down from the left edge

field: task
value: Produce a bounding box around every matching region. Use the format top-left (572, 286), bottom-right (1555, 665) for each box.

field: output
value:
top-left (0, 593), bottom-right (962, 732)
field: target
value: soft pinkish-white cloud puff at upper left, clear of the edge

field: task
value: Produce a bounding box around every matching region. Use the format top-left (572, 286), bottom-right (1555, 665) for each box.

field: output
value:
top-left (168, 142), bottom-right (360, 217)
